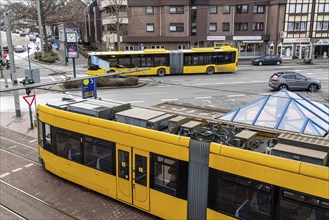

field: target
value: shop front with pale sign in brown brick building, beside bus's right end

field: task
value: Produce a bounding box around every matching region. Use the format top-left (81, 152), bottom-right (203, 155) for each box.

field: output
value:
top-left (233, 36), bottom-right (265, 58)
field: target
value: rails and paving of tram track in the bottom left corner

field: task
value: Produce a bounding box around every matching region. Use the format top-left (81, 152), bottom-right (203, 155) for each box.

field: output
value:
top-left (0, 180), bottom-right (79, 220)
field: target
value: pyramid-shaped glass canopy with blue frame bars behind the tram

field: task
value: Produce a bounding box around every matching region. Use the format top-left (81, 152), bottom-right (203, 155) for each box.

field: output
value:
top-left (219, 90), bottom-right (329, 137)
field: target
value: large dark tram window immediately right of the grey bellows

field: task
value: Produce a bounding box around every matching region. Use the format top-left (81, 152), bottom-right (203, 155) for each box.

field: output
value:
top-left (208, 169), bottom-right (271, 219)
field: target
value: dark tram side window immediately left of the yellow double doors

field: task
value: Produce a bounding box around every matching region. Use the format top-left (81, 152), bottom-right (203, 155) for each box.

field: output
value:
top-left (84, 136), bottom-right (115, 175)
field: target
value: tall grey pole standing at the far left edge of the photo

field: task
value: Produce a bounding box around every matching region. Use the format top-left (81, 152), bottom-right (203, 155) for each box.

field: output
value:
top-left (4, 12), bottom-right (21, 117)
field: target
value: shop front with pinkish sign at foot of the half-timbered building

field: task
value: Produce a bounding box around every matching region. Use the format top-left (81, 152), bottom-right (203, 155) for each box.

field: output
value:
top-left (278, 38), bottom-right (313, 59)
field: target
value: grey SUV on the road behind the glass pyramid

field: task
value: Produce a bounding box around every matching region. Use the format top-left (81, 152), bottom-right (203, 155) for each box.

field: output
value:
top-left (268, 72), bottom-right (321, 92)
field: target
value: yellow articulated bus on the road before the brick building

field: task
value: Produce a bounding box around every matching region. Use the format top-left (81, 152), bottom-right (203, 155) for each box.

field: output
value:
top-left (88, 46), bottom-right (238, 76)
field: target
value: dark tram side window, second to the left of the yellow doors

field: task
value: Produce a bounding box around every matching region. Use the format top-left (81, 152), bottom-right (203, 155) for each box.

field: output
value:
top-left (56, 128), bottom-right (81, 163)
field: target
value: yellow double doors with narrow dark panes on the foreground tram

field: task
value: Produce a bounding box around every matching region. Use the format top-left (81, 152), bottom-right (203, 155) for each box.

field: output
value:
top-left (117, 145), bottom-right (150, 211)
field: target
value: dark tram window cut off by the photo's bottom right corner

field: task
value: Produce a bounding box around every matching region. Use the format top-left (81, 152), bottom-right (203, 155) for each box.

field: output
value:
top-left (279, 190), bottom-right (329, 220)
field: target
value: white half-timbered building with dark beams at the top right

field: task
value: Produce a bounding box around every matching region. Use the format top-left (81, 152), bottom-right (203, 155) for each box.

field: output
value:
top-left (278, 0), bottom-right (329, 59)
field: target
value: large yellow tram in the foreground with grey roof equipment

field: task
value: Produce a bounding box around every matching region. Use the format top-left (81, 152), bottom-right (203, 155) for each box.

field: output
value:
top-left (37, 100), bottom-right (329, 220)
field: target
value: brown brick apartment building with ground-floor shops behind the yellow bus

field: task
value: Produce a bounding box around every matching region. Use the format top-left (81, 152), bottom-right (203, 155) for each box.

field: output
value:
top-left (121, 0), bottom-right (286, 57)
